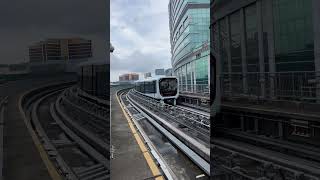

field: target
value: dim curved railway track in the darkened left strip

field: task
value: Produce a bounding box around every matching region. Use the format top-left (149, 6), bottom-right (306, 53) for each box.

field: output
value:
top-left (21, 85), bottom-right (110, 180)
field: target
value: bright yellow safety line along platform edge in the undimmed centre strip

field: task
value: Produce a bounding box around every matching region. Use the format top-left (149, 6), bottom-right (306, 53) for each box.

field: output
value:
top-left (116, 91), bottom-right (164, 180)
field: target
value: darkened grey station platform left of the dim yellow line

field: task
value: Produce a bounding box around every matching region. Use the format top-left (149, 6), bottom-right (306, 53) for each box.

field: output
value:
top-left (3, 92), bottom-right (51, 180)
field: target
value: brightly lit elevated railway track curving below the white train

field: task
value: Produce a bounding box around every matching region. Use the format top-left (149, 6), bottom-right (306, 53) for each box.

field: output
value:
top-left (118, 89), bottom-right (210, 179)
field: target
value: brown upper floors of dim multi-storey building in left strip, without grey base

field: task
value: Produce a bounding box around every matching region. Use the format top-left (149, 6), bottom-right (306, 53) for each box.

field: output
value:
top-left (29, 38), bottom-right (92, 62)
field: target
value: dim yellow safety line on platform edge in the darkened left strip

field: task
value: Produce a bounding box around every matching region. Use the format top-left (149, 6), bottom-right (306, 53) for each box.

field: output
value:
top-left (19, 91), bottom-right (62, 180)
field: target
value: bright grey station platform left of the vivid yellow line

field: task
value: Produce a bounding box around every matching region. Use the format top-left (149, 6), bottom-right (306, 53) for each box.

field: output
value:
top-left (111, 88), bottom-right (155, 180)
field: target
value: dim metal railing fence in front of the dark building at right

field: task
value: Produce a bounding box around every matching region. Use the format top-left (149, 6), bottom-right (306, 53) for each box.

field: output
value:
top-left (220, 71), bottom-right (320, 101)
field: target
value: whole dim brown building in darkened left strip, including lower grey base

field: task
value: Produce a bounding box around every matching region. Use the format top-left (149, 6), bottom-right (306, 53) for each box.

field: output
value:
top-left (29, 38), bottom-right (92, 74)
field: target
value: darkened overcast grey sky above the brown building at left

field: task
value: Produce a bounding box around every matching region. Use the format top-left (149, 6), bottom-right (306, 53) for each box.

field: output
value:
top-left (0, 0), bottom-right (109, 64)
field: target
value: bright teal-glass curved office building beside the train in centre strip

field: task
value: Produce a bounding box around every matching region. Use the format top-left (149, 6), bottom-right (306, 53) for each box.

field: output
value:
top-left (168, 0), bottom-right (210, 93)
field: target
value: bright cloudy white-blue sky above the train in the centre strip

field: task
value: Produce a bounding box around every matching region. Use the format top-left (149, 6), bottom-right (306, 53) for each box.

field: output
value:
top-left (110, 0), bottom-right (171, 81)
